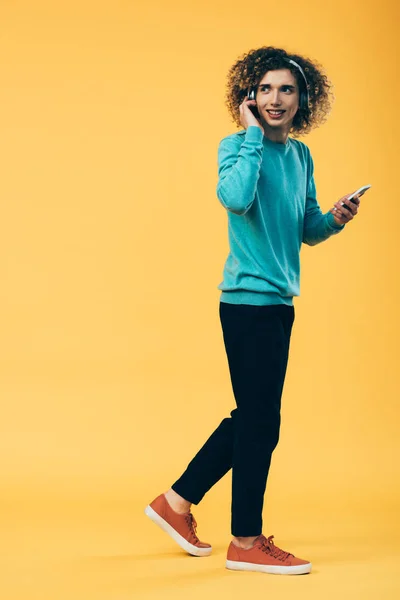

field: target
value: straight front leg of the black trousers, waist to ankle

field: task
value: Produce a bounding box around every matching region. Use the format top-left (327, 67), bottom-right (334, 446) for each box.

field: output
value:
top-left (221, 304), bottom-right (294, 537)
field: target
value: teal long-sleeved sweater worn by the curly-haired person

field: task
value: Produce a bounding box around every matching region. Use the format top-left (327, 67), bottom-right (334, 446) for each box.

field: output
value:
top-left (217, 125), bottom-right (345, 305)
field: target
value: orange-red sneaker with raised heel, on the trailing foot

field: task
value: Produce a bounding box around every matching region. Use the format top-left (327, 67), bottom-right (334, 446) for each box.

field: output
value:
top-left (144, 494), bottom-right (212, 556)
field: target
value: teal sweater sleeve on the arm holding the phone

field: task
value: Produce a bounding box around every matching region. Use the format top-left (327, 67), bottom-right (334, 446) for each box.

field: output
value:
top-left (303, 151), bottom-right (345, 246)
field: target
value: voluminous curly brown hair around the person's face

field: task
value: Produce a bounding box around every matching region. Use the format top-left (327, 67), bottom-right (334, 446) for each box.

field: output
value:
top-left (225, 46), bottom-right (335, 138)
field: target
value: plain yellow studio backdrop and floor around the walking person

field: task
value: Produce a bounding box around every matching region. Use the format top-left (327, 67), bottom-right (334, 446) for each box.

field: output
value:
top-left (0, 0), bottom-right (400, 600)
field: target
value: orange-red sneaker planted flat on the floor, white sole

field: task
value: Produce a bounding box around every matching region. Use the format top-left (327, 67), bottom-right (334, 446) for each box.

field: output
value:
top-left (226, 534), bottom-right (312, 575)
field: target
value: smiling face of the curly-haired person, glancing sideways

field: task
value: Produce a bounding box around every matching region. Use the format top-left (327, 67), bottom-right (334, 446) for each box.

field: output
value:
top-left (256, 69), bottom-right (299, 131)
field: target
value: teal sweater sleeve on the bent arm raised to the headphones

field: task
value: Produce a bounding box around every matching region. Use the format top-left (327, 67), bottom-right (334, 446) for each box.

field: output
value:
top-left (217, 125), bottom-right (263, 215)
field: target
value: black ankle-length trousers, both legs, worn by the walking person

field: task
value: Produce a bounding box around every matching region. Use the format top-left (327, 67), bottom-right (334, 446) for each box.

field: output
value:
top-left (171, 302), bottom-right (294, 537)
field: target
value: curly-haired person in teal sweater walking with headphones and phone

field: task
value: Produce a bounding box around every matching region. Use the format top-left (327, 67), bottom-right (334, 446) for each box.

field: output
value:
top-left (145, 46), bottom-right (360, 574)
